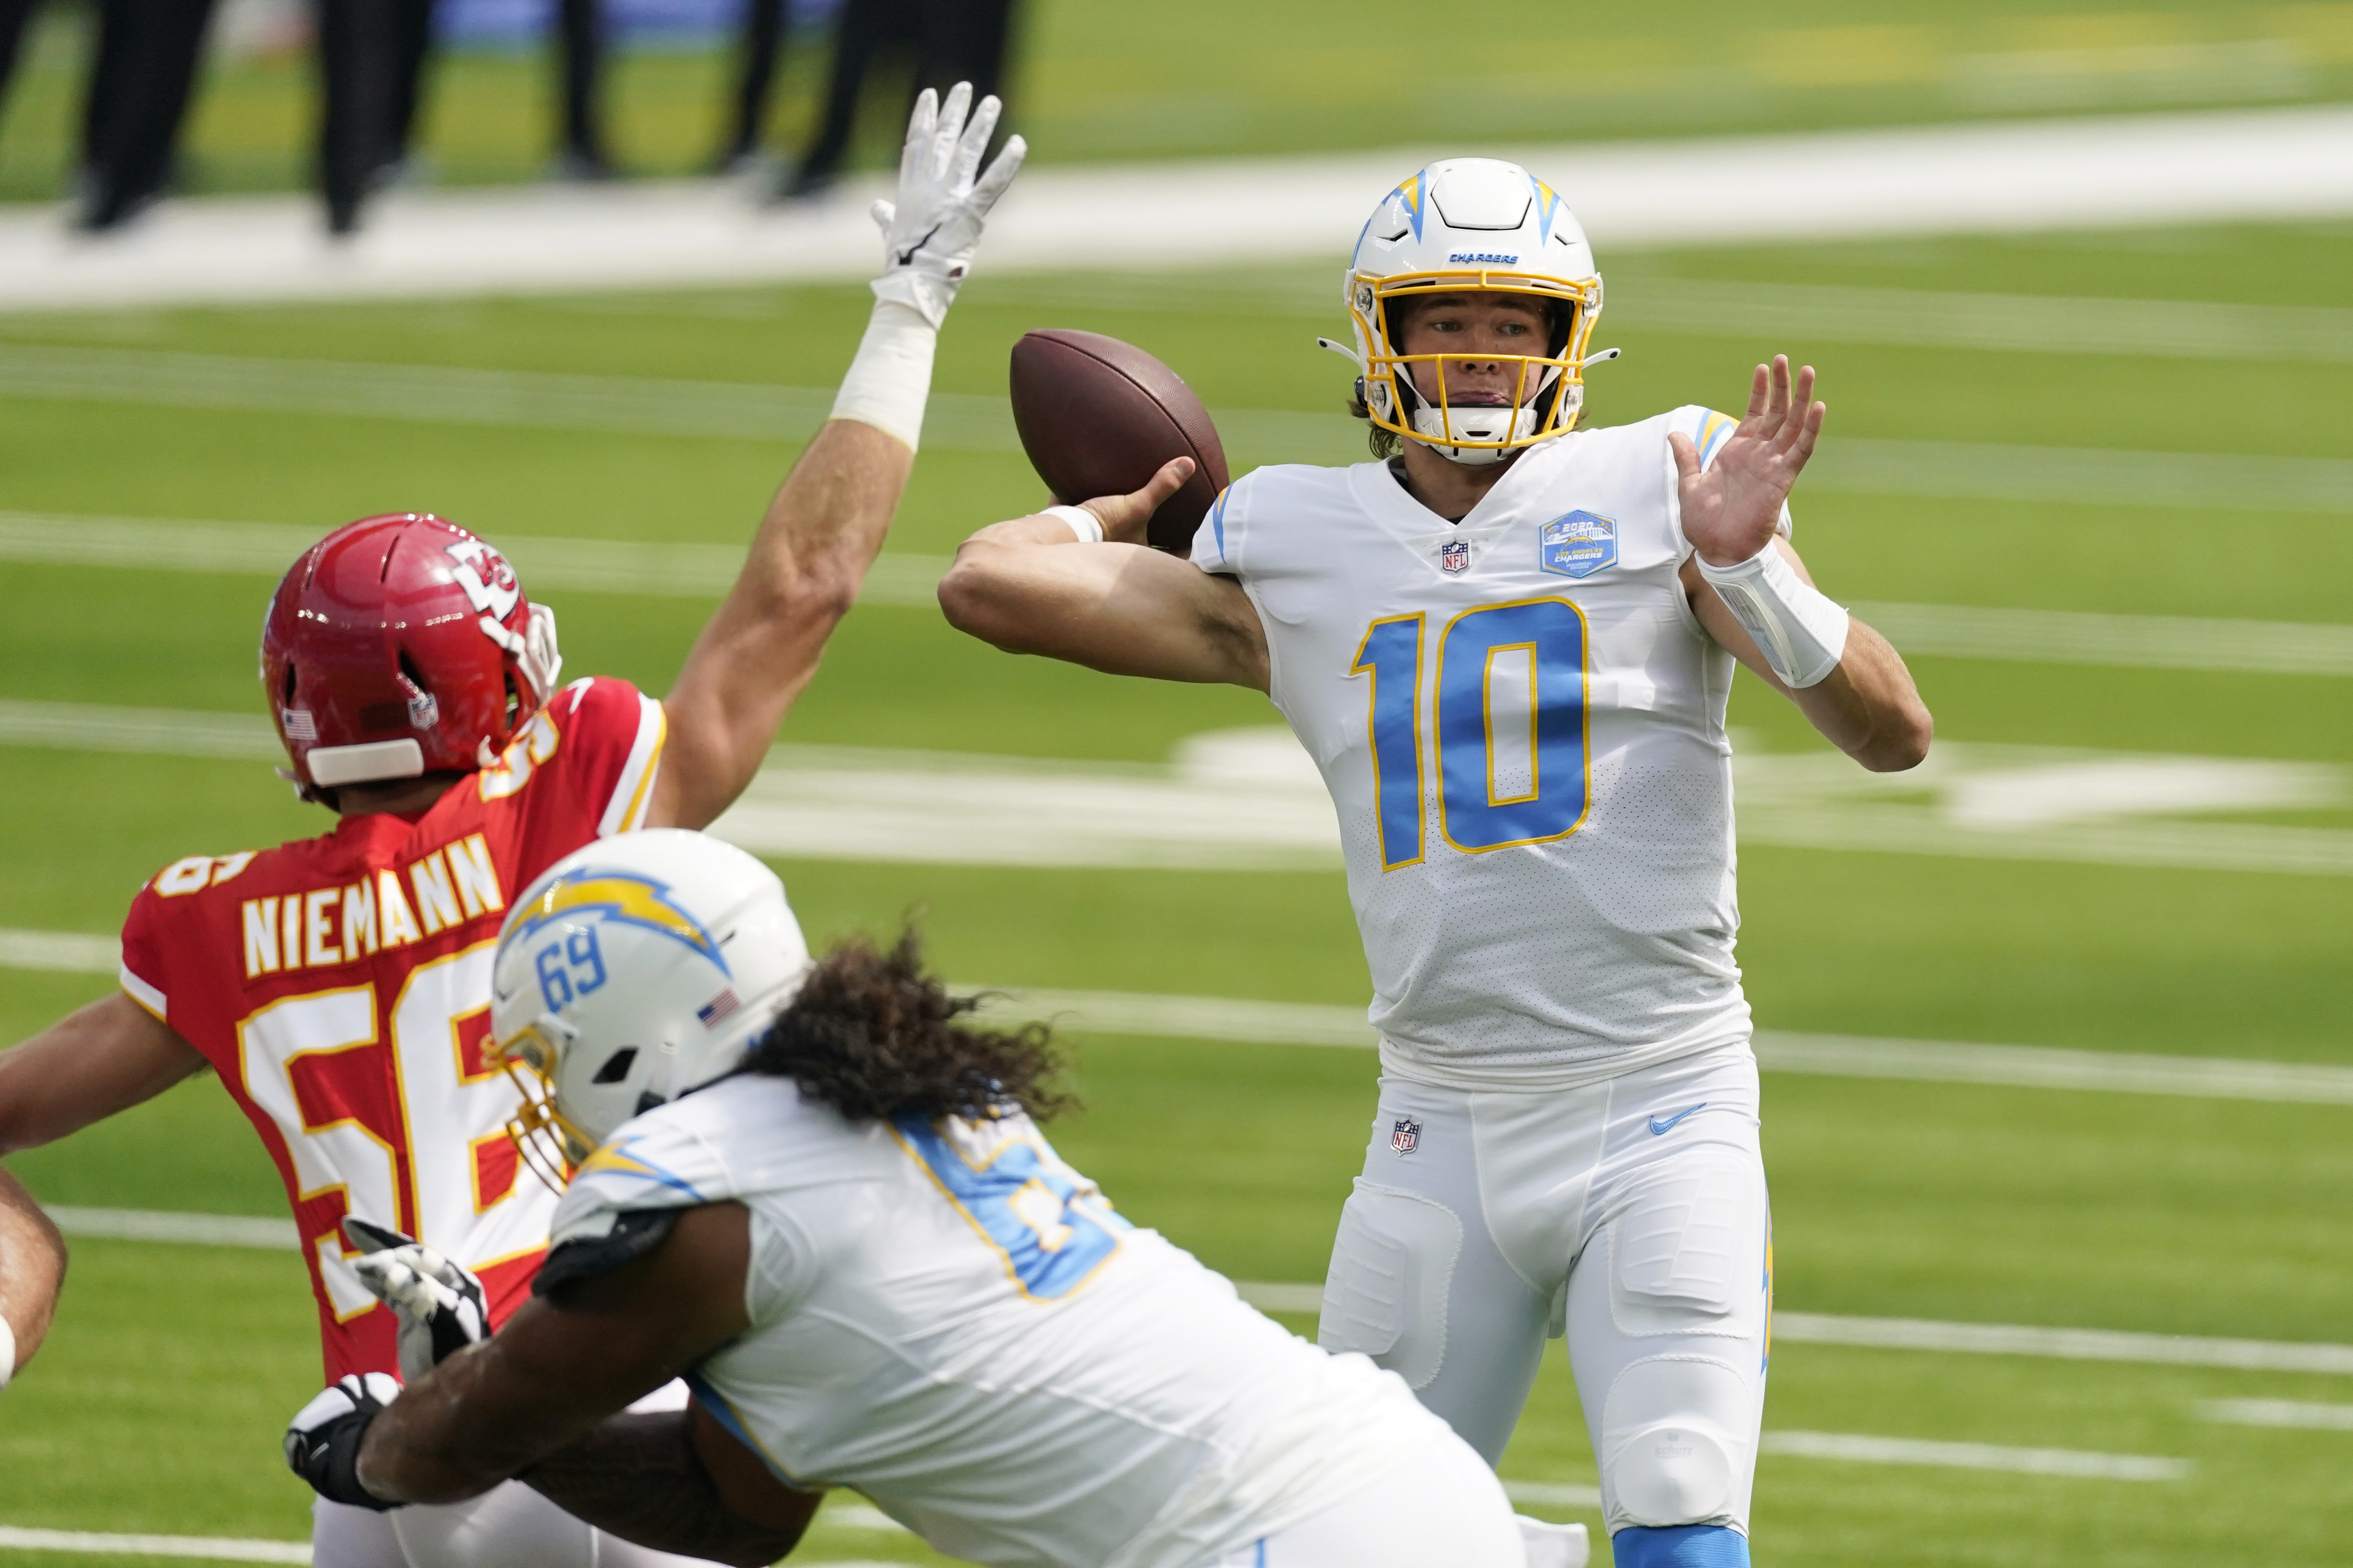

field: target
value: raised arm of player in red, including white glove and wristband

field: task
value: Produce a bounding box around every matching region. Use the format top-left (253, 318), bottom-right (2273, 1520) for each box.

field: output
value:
top-left (649, 82), bottom-right (1026, 829)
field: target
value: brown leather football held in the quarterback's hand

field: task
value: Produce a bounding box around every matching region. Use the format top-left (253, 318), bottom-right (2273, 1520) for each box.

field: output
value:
top-left (1012, 327), bottom-right (1226, 553)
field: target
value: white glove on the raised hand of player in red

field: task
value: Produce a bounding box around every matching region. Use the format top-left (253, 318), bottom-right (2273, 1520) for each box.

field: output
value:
top-left (873, 82), bottom-right (1028, 327)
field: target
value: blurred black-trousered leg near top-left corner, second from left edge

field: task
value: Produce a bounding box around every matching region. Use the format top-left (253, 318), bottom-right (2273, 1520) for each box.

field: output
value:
top-left (73, 0), bottom-right (216, 233)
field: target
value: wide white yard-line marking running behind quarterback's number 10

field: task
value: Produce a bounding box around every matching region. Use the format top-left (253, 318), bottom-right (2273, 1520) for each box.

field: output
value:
top-left (0, 702), bottom-right (2353, 876)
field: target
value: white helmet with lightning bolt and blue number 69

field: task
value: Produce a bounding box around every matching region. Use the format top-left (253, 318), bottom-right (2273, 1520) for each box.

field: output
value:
top-left (489, 829), bottom-right (810, 1189)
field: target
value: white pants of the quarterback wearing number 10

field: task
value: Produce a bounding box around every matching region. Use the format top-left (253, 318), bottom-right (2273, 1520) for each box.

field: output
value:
top-left (1318, 1043), bottom-right (1772, 1533)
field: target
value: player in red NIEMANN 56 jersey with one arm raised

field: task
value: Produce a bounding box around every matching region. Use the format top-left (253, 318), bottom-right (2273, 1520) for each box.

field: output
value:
top-left (0, 87), bottom-right (1024, 1568)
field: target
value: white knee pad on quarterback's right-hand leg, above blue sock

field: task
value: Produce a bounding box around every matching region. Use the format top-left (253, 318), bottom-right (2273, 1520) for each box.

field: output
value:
top-left (1600, 1356), bottom-right (1756, 1516)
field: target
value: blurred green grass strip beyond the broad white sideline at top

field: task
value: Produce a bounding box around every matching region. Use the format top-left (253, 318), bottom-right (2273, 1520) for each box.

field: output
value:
top-left (0, 0), bottom-right (2353, 200)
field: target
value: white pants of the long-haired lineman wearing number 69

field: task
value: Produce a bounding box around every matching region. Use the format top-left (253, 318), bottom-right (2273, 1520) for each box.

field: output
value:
top-left (1202, 1436), bottom-right (1527, 1568)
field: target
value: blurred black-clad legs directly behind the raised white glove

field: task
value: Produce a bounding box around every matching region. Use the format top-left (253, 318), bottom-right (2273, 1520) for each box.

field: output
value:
top-left (779, 0), bottom-right (1014, 200)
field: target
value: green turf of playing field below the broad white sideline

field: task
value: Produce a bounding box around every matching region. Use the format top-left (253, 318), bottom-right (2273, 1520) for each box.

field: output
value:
top-left (0, 201), bottom-right (2353, 1568)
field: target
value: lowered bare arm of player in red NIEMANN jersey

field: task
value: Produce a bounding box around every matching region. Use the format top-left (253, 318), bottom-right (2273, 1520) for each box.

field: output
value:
top-left (0, 991), bottom-right (205, 1154)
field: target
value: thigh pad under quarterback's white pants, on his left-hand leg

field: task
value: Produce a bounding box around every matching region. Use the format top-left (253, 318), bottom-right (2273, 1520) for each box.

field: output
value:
top-left (1315, 1177), bottom-right (1464, 1389)
